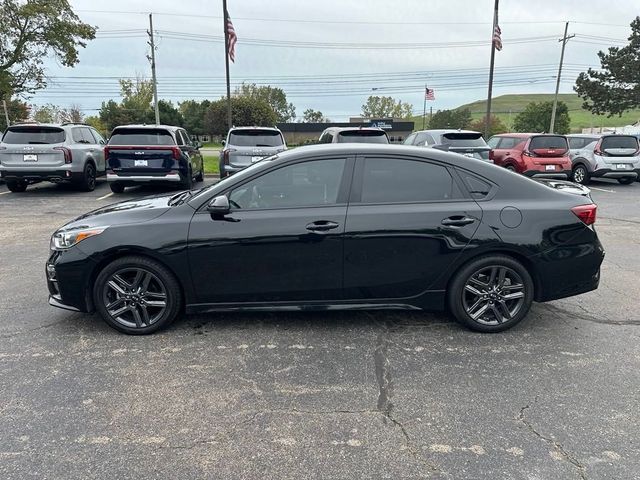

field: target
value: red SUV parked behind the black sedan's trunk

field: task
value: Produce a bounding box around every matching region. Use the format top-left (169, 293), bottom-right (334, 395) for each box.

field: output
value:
top-left (487, 133), bottom-right (571, 179)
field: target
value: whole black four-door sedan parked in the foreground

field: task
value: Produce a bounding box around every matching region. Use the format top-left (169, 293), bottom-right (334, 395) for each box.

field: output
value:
top-left (46, 144), bottom-right (604, 334)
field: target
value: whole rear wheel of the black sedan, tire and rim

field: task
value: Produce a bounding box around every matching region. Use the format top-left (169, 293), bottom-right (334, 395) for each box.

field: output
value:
top-left (447, 255), bottom-right (534, 333)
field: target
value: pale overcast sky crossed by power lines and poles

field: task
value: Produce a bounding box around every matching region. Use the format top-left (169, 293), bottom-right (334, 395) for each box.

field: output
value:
top-left (31, 0), bottom-right (640, 121)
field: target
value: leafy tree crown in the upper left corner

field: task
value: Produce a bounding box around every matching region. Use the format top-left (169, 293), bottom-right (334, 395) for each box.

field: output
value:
top-left (0, 0), bottom-right (96, 99)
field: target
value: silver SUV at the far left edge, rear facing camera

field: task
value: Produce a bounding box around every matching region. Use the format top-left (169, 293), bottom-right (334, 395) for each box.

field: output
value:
top-left (0, 122), bottom-right (105, 192)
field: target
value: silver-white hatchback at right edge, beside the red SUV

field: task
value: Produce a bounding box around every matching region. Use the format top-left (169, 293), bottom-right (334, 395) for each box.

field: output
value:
top-left (569, 135), bottom-right (640, 185)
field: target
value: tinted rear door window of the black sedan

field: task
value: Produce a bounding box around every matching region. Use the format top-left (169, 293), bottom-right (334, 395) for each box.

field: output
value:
top-left (361, 158), bottom-right (458, 203)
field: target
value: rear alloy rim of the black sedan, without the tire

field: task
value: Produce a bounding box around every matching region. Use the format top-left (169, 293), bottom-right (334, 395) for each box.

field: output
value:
top-left (462, 265), bottom-right (525, 325)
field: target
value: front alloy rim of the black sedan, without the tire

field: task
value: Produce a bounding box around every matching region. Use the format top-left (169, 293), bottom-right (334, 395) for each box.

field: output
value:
top-left (102, 267), bottom-right (167, 328)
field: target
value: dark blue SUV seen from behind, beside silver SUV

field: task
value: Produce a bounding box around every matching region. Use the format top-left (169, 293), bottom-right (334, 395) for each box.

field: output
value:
top-left (104, 125), bottom-right (204, 193)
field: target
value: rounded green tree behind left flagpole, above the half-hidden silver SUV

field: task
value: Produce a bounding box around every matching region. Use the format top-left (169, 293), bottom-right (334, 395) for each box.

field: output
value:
top-left (204, 97), bottom-right (278, 135)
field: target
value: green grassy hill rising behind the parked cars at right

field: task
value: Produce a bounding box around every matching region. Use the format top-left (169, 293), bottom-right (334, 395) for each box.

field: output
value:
top-left (412, 93), bottom-right (640, 132)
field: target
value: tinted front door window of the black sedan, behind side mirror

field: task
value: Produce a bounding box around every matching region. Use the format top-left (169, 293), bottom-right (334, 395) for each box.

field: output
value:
top-left (229, 158), bottom-right (346, 209)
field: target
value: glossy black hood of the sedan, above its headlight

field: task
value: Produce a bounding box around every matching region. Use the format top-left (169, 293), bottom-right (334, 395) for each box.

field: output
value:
top-left (59, 192), bottom-right (175, 231)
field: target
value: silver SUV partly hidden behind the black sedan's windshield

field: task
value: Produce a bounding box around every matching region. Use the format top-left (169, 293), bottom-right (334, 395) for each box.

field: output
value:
top-left (220, 127), bottom-right (287, 178)
